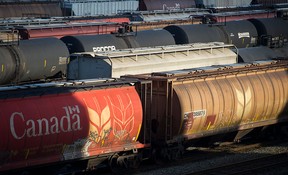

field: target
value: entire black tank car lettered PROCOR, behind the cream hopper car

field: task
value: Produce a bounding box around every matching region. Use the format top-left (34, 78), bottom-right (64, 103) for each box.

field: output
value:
top-left (61, 29), bottom-right (175, 53)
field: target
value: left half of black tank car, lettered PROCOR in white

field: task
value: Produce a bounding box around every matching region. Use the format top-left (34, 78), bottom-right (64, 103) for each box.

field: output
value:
top-left (61, 34), bottom-right (128, 53)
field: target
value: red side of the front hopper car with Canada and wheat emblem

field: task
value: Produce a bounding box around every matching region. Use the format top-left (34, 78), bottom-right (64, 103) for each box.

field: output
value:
top-left (0, 80), bottom-right (142, 171)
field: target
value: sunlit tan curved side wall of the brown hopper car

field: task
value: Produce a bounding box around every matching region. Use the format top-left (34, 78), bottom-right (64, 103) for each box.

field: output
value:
top-left (173, 69), bottom-right (288, 135)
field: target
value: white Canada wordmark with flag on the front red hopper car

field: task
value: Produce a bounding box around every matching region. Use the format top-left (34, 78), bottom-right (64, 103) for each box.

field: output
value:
top-left (10, 105), bottom-right (82, 140)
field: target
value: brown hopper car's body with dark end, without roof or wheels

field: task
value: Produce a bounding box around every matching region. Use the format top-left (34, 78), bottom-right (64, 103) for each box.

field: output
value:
top-left (143, 62), bottom-right (288, 140)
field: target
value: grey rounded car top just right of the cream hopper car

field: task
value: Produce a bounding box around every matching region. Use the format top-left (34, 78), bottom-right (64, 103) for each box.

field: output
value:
top-left (238, 46), bottom-right (283, 63)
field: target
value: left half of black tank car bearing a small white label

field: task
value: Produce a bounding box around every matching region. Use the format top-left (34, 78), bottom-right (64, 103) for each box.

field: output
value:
top-left (164, 24), bottom-right (228, 44)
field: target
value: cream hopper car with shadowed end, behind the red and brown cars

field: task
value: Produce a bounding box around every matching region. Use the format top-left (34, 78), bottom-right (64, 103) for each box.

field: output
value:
top-left (67, 43), bottom-right (238, 80)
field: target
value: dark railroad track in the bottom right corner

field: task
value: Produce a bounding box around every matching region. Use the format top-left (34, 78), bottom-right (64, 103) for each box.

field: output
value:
top-left (186, 152), bottom-right (288, 175)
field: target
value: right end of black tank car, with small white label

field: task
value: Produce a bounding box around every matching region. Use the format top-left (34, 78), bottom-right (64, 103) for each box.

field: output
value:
top-left (223, 20), bottom-right (258, 48)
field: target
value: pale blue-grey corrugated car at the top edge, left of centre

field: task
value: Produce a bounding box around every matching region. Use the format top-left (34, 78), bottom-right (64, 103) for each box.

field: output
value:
top-left (71, 0), bottom-right (139, 16)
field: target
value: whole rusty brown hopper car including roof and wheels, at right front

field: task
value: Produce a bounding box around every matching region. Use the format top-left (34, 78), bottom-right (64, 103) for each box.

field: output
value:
top-left (128, 61), bottom-right (288, 152)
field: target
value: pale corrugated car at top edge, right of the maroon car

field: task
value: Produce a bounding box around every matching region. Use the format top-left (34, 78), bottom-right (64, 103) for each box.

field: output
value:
top-left (195, 0), bottom-right (252, 7)
